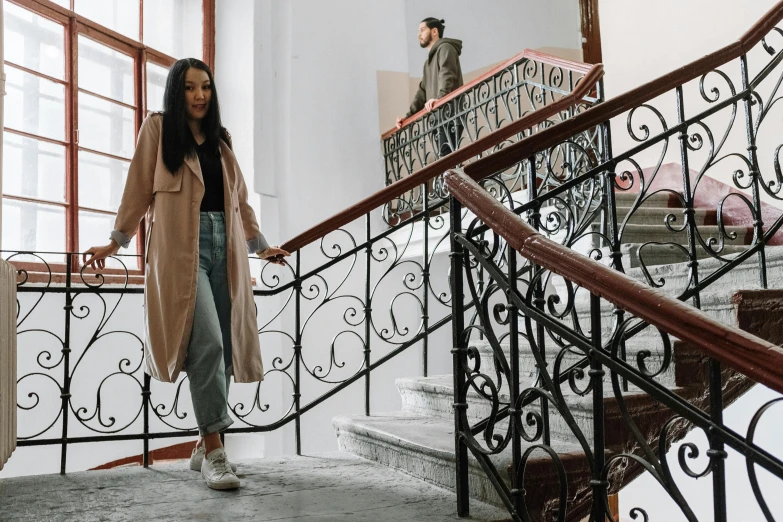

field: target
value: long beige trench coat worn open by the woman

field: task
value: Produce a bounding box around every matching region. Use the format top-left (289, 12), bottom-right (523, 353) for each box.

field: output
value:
top-left (112, 114), bottom-right (265, 382)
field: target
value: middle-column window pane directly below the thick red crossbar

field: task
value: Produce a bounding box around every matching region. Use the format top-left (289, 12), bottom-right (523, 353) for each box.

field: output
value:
top-left (79, 36), bottom-right (135, 105)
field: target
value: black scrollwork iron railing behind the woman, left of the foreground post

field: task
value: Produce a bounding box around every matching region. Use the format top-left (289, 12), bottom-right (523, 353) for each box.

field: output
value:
top-left (2, 192), bottom-right (462, 473)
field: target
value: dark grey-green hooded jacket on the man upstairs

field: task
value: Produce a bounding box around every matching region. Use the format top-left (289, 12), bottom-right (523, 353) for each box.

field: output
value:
top-left (405, 38), bottom-right (463, 118)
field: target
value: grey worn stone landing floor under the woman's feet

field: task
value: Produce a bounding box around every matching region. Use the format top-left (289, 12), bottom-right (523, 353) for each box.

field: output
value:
top-left (0, 453), bottom-right (508, 522)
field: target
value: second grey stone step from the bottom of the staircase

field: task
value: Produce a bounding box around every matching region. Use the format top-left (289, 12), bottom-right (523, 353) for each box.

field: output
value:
top-left (396, 375), bottom-right (695, 447)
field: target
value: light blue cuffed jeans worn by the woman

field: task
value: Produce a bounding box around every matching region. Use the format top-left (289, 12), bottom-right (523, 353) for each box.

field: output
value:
top-left (185, 212), bottom-right (234, 436)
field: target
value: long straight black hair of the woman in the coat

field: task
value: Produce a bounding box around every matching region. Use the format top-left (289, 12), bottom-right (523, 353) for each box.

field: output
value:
top-left (161, 58), bottom-right (231, 174)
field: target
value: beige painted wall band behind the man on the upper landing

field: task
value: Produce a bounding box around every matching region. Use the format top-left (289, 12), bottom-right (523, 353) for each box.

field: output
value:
top-left (378, 47), bottom-right (582, 134)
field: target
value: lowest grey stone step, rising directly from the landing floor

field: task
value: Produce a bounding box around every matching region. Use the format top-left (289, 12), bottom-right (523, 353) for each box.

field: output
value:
top-left (332, 412), bottom-right (590, 509)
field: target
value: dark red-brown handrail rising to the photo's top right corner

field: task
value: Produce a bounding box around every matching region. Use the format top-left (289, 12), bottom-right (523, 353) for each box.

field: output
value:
top-left (464, 1), bottom-right (783, 180)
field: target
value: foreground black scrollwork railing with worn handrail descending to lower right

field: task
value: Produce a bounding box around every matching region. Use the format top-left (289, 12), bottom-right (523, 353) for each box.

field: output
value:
top-left (446, 172), bottom-right (783, 522)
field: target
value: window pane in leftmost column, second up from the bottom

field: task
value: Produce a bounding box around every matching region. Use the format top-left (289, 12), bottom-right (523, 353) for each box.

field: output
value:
top-left (3, 132), bottom-right (65, 202)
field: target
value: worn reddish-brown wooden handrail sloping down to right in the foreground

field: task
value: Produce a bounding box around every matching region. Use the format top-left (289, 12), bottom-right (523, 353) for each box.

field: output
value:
top-left (444, 171), bottom-right (783, 393)
